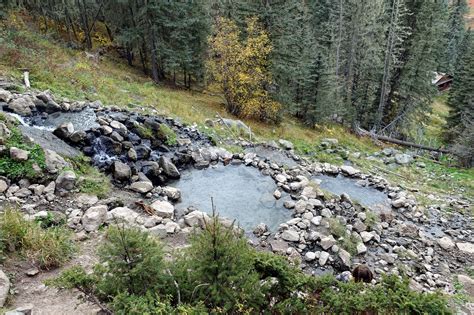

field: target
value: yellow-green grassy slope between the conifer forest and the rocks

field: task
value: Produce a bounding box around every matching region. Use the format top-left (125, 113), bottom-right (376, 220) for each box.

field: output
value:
top-left (0, 12), bottom-right (474, 207)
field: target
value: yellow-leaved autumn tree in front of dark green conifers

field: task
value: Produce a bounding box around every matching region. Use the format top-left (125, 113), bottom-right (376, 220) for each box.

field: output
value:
top-left (207, 17), bottom-right (281, 122)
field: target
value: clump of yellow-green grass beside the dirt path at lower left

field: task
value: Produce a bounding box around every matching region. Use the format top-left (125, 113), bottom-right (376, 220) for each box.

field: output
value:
top-left (0, 208), bottom-right (75, 269)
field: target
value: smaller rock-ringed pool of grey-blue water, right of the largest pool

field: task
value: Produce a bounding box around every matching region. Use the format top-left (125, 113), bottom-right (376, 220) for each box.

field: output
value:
top-left (314, 175), bottom-right (390, 210)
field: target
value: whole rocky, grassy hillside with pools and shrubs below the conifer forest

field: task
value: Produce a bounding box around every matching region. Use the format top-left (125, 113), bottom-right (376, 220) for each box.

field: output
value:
top-left (0, 11), bottom-right (474, 314)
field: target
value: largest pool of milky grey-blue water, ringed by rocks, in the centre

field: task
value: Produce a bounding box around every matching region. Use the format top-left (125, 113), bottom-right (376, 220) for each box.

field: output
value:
top-left (173, 165), bottom-right (292, 232)
